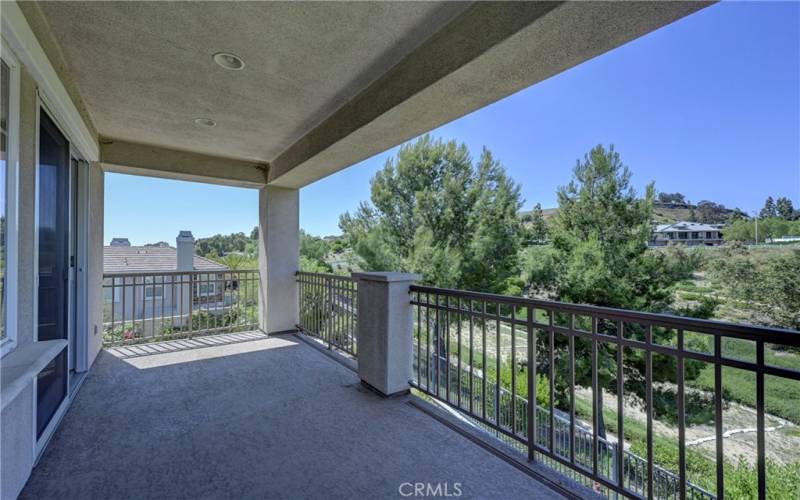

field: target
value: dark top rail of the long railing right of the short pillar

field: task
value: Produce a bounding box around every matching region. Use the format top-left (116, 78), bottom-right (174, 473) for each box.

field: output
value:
top-left (410, 285), bottom-right (800, 346)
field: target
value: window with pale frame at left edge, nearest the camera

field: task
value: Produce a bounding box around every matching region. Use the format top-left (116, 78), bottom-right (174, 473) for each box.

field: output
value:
top-left (0, 40), bottom-right (19, 354)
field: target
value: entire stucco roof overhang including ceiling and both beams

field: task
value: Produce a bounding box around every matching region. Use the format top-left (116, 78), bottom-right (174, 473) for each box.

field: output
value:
top-left (20, 1), bottom-right (709, 188)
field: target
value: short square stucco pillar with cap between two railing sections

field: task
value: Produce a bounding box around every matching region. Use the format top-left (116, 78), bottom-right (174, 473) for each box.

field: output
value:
top-left (353, 273), bottom-right (420, 396)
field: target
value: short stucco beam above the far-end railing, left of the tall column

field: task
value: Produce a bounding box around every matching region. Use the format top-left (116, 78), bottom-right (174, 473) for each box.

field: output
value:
top-left (100, 139), bottom-right (267, 188)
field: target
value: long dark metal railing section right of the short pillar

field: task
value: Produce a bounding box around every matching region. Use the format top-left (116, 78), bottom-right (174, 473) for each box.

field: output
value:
top-left (411, 286), bottom-right (800, 499)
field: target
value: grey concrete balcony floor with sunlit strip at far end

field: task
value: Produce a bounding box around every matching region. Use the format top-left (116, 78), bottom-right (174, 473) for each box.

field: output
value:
top-left (21, 334), bottom-right (561, 499)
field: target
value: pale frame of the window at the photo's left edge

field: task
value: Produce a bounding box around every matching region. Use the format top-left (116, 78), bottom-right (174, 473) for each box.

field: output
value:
top-left (0, 38), bottom-right (20, 357)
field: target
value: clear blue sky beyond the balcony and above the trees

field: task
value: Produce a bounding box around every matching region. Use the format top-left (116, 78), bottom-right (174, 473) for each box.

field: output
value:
top-left (105, 2), bottom-right (800, 244)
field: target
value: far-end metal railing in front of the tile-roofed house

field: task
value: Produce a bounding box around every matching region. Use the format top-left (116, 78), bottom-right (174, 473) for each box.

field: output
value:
top-left (103, 270), bottom-right (259, 346)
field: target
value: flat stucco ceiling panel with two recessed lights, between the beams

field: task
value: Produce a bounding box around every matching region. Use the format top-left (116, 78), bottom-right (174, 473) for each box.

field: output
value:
top-left (40, 2), bottom-right (466, 161)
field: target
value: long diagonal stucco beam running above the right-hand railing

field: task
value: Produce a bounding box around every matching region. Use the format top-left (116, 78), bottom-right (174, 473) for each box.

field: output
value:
top-left (269, 1), bottom-right (711, 188)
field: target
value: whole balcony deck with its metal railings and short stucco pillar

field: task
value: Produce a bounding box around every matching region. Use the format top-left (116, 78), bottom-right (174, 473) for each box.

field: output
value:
top-left (21, 271), bottom-right (800, 499)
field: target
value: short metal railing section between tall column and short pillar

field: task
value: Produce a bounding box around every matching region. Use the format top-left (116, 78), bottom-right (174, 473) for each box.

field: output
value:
top-left (297, 271), bottom-right (358, 356)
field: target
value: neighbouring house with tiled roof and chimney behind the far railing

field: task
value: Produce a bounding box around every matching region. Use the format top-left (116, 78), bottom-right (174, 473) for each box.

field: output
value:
top-left (103, 231), bottom-right (230, 336)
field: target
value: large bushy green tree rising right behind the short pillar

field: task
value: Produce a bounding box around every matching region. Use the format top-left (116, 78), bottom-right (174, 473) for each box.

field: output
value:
top-left (339, 135), bottom-right (521, 292)
